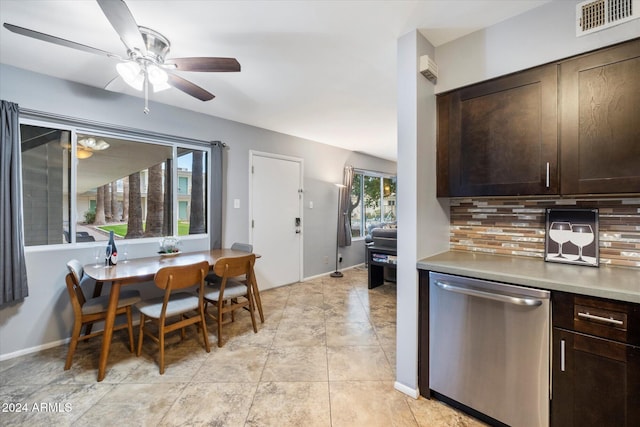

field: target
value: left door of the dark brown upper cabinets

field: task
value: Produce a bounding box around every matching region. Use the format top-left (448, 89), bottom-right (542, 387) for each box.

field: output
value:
top-left (438, 65), bottom-right (558, 196)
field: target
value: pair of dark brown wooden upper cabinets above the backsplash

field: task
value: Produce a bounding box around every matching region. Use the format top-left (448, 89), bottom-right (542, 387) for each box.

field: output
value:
top-left (437, 38), bottom-right (640, 197)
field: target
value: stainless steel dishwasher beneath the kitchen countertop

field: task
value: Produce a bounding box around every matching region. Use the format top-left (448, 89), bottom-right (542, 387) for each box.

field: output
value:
top-left (429, 272), bottom-right (550, 427)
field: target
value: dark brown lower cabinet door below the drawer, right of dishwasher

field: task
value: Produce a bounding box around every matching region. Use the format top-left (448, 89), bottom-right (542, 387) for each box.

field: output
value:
top-left (551, 328), bottom-right (640, 427)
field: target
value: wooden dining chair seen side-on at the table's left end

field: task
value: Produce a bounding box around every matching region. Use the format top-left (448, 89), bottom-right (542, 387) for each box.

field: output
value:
top-left (64, 260), bottom-right (140, 371)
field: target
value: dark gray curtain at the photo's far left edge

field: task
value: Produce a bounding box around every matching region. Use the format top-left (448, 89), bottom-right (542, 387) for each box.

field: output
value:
top-left (0, 101), bottom-right (29, 306)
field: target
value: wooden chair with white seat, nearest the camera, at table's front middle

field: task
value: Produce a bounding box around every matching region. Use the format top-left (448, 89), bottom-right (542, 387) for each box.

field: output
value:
top-left (136, 261), bottom-right (210, 374)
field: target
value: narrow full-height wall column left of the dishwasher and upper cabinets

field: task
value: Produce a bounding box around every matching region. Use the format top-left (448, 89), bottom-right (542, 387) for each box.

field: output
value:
top-left (395, 31), bottom-right (449, 397)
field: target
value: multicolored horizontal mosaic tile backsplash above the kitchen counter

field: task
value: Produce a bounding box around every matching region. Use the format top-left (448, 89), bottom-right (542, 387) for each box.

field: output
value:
top-left (450, 198), bottom-right (640, 268)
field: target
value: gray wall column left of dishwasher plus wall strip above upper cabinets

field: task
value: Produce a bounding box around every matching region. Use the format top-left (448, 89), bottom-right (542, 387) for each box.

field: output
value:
top-left (395, 0), bottom-right (640, 395)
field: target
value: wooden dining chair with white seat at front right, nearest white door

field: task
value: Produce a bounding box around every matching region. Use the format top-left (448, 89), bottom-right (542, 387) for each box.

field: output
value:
top-left (204, 254), bottom-right (258, 347)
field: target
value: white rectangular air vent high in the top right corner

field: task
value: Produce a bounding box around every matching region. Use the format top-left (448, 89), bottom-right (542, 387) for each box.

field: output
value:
top-left (576, 0), bottom-right (640, 36)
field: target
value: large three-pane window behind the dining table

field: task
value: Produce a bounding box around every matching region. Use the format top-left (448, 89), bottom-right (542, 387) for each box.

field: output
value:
top-left (20, 121), bottom-right (208, 246)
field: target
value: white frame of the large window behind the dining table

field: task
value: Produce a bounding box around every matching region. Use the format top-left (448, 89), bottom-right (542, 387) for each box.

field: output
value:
top-left (18, 109), bottom-right (212, 251)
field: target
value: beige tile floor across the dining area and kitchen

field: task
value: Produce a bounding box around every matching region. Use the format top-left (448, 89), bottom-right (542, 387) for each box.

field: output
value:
top-left (0, 268), bottom-right (483, 427)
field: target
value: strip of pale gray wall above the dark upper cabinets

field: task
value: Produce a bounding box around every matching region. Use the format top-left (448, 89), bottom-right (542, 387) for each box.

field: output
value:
top-left (435, 0), bottom-right (640, 93)
